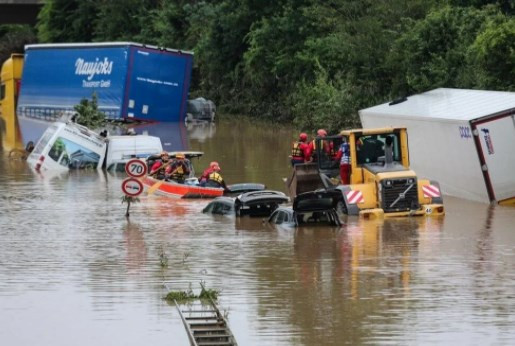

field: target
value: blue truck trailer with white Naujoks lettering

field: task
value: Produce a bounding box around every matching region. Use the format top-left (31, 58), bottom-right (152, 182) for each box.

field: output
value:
top-left (16, 42), bottom-right (193, 145)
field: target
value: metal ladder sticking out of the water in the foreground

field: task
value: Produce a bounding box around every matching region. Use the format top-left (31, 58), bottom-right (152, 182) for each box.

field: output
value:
top-left (174, 299), bottom-right (238, 346)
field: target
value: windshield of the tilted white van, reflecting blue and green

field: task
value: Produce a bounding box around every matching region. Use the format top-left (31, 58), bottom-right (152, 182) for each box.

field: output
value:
top-left (48, 137), bottom-right (100, 169)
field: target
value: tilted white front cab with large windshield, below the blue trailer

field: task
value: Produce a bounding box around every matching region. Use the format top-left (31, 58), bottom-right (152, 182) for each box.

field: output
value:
top-left (27, 122), bottom-right (106, 171)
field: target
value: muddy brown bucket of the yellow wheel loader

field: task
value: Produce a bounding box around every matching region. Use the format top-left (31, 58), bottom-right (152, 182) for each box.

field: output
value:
top-left (286, 163), bottom-right (326, 200)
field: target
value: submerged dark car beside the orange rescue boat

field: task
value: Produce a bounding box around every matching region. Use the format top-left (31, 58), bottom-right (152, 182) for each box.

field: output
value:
top-left (202, 190), bottom-right (289, 216)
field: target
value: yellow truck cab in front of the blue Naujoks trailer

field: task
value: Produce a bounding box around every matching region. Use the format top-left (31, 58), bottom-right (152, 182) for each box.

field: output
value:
top-left (0, 54), bottom-right (23, 150)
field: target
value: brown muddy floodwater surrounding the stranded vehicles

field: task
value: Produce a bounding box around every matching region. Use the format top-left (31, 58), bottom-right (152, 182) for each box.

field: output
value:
top-left (0, 122), bottom-right (515, 346)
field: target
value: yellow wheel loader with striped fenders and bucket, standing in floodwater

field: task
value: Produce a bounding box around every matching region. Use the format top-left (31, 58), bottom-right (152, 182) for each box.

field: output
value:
top-left (286, 127), bottom-right (445, 218)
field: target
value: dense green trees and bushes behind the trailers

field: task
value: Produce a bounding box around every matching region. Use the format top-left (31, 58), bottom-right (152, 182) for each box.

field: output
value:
top-left (31, 0), bottom-right (515, 130)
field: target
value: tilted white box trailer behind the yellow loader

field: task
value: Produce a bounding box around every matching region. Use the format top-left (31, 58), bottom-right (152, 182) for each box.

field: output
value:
top-left (359, 88), bottom-right (515, 204)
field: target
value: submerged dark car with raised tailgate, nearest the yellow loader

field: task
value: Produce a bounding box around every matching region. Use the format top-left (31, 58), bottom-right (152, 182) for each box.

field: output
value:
top-left (267, 190), bottom-right (342, 226)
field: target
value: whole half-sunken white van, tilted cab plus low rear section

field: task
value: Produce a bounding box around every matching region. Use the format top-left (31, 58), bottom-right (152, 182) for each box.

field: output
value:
top-left (27, 122), bottom-right (163, 172)
